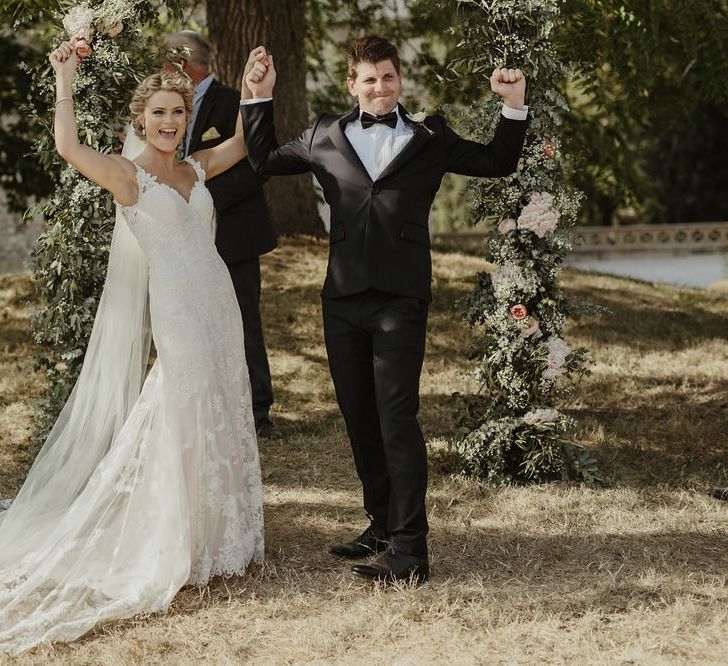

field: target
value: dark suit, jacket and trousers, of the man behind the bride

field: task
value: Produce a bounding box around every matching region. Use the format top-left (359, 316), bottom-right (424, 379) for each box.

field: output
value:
top-left (188, 80), bottom-right (276, 424)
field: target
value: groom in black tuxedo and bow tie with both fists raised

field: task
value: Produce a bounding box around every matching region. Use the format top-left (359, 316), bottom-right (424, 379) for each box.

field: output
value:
top-left (241, 36), bottom-right (527, 582)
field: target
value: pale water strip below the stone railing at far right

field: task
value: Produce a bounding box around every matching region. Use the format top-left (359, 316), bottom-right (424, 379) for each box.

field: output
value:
top-left (566, 252), bottom-right (728, 287)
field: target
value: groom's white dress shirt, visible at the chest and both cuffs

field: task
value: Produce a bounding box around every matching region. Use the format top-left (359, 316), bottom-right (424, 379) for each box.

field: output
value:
top-left (240, 97), bottom-right (528, 180)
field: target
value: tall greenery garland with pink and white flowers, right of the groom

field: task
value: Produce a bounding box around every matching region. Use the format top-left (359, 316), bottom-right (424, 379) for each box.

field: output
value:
top-left (449, 0), bottom-right (601, 483)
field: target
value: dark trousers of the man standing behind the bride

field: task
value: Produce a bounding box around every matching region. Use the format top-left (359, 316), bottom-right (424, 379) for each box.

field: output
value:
top-left (228, 257), bottom-right (273, 423)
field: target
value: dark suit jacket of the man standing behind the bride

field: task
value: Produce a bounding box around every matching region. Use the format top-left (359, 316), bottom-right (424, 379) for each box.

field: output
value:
top-left (190, 81), bottom-right (276, 264)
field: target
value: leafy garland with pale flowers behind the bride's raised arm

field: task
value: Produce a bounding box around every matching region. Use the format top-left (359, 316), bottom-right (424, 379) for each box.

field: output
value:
top-left (29, 0), bottom-right (183, 439)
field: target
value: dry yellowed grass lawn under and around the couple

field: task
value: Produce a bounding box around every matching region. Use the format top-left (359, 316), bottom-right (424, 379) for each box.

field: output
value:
top-left (0, 240), bottom-right (728, 665)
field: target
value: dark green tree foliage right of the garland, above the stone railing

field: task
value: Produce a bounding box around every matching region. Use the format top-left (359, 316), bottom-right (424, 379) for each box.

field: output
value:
top-left (556, 0), bottom-right (728, 224)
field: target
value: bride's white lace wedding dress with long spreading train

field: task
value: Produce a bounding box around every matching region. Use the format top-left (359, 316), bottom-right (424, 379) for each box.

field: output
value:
top-left (0, 158), bottom-right (263, 654)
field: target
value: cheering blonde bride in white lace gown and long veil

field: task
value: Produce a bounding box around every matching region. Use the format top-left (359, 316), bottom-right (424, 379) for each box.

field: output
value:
top-left (0, 42), bottom-right (263, 653)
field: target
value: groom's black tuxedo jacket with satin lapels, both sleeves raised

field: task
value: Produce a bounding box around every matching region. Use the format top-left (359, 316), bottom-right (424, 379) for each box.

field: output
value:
top-left (240, 102), bottom-right (528, 300)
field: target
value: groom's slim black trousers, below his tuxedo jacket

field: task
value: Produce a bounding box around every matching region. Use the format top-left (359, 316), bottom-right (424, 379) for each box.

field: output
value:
top-left (323, 290), bottom-right (428, 557)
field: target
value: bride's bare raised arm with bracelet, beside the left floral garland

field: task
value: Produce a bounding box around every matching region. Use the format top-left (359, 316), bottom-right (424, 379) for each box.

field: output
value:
top-left (49, 42), bottom-right (138, 205)
